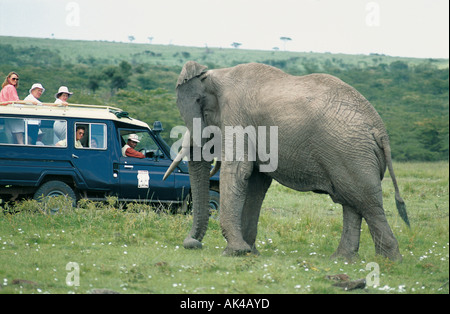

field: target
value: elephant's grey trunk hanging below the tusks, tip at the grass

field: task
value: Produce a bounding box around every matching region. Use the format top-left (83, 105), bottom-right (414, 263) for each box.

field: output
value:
top-left (183, 161), bottom-right (211, 249)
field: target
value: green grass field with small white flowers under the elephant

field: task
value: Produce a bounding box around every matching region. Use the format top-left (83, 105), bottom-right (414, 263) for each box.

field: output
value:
top-left (0, 162), bottom-right (449, 294)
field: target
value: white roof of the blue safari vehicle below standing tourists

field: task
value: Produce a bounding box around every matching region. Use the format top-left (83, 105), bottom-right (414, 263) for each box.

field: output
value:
top-left (0, 101), bottom-right (149, 128)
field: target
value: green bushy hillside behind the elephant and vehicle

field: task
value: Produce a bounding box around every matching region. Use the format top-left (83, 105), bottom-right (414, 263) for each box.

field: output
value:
top-left (0, 36), bottom-right (449, 161)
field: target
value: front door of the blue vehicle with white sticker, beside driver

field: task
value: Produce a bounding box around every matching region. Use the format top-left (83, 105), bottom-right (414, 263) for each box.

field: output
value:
top-left (117, 129), bottom-right (176, 202)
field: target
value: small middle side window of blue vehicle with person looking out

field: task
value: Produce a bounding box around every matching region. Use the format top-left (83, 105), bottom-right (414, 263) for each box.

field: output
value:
top-left (75, 123), bottom-right (107, 150)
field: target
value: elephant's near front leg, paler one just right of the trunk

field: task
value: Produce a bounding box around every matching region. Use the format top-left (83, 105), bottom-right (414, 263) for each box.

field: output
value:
top-left (220, 161), bottom-right (253, 256)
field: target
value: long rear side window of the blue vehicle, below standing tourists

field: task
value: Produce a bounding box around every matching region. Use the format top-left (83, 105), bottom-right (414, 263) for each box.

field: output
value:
top-left (0, 117), bottom-right (67, 147)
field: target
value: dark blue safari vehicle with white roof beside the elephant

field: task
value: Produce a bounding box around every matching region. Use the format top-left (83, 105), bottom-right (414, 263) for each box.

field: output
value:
top-left (0, 102), bottom-right (219, 211)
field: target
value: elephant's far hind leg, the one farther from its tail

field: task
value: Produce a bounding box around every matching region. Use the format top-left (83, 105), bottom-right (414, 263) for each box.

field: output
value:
top-left (332, 205), bottom-right (362, 260)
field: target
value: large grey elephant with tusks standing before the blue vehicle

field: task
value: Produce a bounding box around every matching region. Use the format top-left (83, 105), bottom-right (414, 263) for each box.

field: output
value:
top-left (166, 61), bottom-right (409, 260)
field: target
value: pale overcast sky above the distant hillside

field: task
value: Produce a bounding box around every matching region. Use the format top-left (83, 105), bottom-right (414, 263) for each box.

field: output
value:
top-left (0, 0), bottom-right (449, 59)
